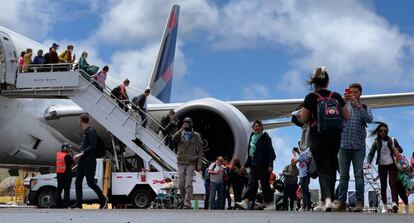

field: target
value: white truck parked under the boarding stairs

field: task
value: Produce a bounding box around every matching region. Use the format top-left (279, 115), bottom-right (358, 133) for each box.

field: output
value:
top-left (26, 159), bottom-right (205, 208)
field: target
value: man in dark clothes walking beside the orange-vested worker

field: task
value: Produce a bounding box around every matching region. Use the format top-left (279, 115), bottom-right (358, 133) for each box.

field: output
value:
top-left (73, 114), bottom-right (108, 209)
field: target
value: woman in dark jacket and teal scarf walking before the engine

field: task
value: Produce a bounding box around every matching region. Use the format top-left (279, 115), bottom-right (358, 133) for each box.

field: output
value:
top-left (236, 120), bottom-right (276, 210)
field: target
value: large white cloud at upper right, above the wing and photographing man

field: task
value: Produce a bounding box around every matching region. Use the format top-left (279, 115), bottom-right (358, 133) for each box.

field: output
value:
top-left (210, 0), bottom-right (414, 93)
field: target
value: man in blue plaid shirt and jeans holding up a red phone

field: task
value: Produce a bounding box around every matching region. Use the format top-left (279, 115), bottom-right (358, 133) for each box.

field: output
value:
top-left (333, 83), bottom-right (372, 212)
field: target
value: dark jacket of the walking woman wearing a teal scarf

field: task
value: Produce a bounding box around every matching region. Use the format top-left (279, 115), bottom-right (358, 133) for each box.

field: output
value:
top-left (245, 132), bottom-right (276, 167)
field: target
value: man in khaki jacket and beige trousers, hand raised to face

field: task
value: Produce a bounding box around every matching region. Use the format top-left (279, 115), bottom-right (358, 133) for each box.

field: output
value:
top-left (173, 117), bottom-right (203, 209)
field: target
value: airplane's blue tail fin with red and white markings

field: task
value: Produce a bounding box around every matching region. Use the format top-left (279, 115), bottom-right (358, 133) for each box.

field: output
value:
top-left (148, 5), bottom-right (180, 103)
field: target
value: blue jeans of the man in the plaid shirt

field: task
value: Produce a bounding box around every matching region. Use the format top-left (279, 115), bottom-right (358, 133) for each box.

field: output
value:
top-left (338, 148), bottom-right (365, 203)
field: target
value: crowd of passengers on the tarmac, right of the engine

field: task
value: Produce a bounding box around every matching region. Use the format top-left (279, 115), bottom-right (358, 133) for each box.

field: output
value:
top-left (204, 67), bottom-right (414, 213)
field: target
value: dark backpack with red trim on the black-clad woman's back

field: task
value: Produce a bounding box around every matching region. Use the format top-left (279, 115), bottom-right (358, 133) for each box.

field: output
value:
top-left (314, 92), bottom-right (343, 134)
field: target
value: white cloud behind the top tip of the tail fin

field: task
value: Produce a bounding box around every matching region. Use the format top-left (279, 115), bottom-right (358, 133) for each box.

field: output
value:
top-left (92, 0), bottom-right (218, 44)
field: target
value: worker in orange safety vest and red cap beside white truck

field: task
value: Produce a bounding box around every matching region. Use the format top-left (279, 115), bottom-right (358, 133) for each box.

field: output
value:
top-left (55, 143), bottom-right (73, 208)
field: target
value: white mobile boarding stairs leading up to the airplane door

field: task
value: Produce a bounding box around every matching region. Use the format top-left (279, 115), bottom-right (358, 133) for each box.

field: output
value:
top-left (1, 67), bottom-right (177, 171)
